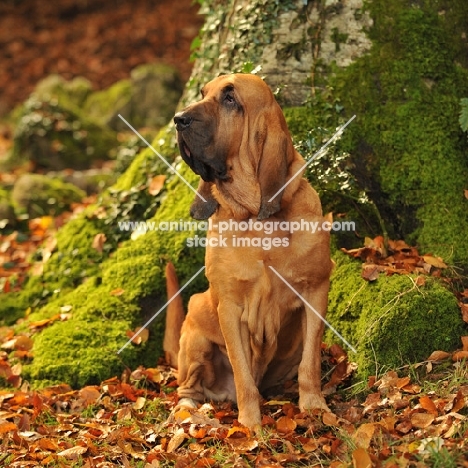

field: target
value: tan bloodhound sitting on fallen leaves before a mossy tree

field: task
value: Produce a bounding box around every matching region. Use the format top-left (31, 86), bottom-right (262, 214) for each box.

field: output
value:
top-left (167, 74), bottom-right (332, 429)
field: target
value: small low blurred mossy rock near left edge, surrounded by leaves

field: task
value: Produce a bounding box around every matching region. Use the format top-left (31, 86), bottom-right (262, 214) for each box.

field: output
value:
top-left (11, 174), bottom-right (86, 218)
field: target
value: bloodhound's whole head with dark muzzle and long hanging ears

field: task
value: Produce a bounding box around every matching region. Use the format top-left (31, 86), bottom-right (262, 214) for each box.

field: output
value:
top-left (174, 74), bottom-right (294, 219)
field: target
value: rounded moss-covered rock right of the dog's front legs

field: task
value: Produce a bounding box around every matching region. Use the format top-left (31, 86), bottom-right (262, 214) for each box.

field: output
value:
top-left (325, 252), bottom-right (467, 378)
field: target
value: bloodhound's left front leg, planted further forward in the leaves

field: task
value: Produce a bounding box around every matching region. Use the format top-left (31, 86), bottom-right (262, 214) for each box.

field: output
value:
top-left (218, 302), bottom-right (261, 431)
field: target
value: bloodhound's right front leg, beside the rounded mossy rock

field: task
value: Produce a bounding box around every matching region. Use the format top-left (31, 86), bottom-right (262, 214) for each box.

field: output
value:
top-left (298, 280), bottom-right (330, 411)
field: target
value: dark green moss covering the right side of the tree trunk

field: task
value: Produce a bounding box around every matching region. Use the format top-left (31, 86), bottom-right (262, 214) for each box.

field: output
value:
top-left (330, 0), bottom-right (468, 266)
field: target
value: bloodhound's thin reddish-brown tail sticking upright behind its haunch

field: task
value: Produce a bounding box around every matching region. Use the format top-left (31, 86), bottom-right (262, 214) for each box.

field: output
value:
top-left (163, 262), bottom-right (185, 368)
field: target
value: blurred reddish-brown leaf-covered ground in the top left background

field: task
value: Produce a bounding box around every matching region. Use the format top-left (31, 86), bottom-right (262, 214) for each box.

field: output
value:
top-left (0, 0), bottom-right (203, 116)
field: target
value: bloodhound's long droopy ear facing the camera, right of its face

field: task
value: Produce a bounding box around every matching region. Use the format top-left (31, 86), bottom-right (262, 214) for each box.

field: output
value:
top-left (256, 102), bottom-right (294, 220)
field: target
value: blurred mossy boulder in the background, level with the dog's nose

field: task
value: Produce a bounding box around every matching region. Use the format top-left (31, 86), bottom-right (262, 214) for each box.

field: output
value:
top-left (84, 64), bottom-right (183, 130)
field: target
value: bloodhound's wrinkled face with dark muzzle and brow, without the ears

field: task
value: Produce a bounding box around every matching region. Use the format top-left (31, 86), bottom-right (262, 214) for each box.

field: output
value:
top-left (174, 75), bottom-right (272, 182)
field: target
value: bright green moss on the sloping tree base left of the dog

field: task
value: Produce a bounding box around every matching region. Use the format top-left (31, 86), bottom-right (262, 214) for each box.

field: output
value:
top-left (17, 153), bottom-right (206, 386)
